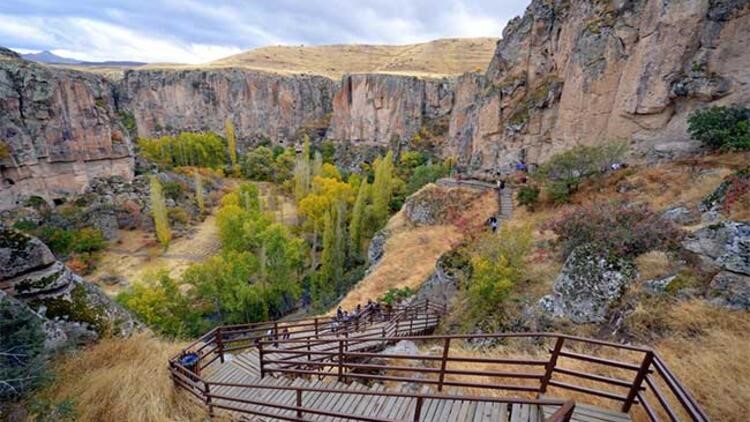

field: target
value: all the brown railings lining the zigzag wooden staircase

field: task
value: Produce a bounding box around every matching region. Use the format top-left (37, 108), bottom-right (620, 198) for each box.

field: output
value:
top-left (169, 301), bottom-right (709, 422)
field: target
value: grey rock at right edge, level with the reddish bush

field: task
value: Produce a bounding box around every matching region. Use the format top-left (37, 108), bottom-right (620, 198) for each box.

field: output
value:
top-left (682, 221), bottom-right (750, 275)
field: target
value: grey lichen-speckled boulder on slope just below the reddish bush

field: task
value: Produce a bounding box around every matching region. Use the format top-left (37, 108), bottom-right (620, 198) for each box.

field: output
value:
top-left (539, 245), bottom-right (637, 324)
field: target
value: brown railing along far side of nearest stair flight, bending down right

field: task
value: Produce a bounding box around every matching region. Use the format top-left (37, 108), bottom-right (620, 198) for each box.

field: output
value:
top-left (261, 333), bottom-right (708, 421)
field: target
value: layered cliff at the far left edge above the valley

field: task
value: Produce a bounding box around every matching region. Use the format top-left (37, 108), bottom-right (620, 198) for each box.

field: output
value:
top-left (0, 50), bottom-right (133, 210)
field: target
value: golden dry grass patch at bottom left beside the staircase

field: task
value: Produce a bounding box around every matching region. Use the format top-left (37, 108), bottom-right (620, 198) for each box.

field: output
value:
top-left (32, 334), bottom-right (223, 422)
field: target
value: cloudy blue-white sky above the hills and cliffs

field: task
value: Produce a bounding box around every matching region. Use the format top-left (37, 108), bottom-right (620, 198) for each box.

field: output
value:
top-left (0, 0), bottom-right (528, 63)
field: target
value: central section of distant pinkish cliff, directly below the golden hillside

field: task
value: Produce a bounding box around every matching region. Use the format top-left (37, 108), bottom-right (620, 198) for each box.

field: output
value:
top-left (326, 74), bottom-right (454, 150)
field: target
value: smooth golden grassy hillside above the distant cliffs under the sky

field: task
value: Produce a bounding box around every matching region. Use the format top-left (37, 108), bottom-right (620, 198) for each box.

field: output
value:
top-left (144, 38), bottom-right (497, 79)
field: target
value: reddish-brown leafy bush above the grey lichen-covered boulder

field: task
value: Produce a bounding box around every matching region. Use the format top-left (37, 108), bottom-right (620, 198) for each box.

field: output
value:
top-left (544, 202), bottom-right (683, 258)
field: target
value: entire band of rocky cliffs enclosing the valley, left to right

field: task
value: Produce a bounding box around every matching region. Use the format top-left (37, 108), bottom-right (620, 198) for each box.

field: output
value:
top-left (0, 0), bottom-right (750, 209)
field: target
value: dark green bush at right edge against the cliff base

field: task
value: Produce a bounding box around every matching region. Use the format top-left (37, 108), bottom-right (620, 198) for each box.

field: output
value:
top-left (688, 106), bottom-right (750, 151)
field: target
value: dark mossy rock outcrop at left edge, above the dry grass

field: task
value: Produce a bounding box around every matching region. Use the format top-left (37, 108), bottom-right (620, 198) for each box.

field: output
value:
top-left (0, 226), bottom-right (141, 338)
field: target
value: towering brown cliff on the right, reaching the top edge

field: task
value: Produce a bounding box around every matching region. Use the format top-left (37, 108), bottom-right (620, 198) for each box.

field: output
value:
top-left (446, 0), bottom-right (750, 172)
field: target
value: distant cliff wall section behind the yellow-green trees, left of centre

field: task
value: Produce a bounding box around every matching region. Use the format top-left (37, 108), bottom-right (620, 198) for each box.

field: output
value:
top-left (119, 69), bottom-right (336, 148)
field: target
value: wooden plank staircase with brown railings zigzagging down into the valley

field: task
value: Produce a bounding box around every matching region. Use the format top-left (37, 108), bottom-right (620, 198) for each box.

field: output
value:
top-left (163, 301), bottom-right (708, 422)
